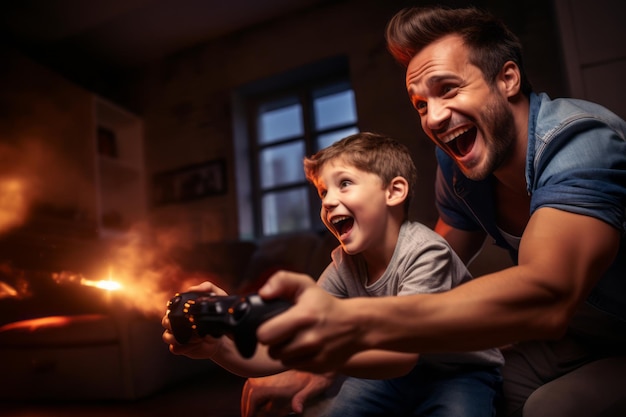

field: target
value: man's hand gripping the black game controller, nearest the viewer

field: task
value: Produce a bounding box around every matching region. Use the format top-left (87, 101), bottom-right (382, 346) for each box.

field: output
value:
top-left (257, 271), bottom-right (366, 373)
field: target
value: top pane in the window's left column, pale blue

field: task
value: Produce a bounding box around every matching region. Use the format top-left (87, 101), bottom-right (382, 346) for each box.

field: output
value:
top-left (259, 103), bottom-right (304, 144)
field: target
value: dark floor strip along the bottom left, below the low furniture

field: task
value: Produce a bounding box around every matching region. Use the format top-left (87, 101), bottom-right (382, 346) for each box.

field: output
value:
top-left (0, 368), bottom-right (245, 417)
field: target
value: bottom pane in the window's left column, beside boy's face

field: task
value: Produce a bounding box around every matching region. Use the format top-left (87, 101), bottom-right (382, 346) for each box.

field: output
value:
top-left (263, 187), bottom-right (311, 236)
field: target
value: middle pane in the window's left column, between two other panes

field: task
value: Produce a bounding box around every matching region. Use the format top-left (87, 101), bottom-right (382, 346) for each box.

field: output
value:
top-left (259, 141), bottom-right (304, 188)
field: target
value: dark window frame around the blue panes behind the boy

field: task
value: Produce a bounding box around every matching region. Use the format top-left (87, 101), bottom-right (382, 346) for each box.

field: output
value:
top-left (233, 56), bottom-right (360, 239)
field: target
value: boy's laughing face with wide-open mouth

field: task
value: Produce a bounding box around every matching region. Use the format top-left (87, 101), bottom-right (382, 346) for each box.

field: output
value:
top-left (316, 159), bottom-right (388, 254)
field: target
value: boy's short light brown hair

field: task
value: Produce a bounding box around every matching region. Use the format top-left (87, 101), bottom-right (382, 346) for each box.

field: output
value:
top-left (304, 132), bottom-right (417, 213)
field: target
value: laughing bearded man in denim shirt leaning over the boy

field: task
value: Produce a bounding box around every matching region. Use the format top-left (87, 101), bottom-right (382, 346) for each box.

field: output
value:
top-left (243, 8), bottom-right (626, 416)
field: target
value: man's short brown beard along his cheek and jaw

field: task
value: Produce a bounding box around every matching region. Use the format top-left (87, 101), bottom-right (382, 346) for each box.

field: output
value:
top-left (463, 95), bottom-right (516, 181)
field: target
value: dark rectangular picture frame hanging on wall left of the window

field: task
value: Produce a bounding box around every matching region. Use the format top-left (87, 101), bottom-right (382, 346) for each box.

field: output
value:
top-left (152, 159), bottom-right (227, 206)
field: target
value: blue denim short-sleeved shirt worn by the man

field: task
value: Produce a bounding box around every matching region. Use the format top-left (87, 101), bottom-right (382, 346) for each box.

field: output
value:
top-left (435, 94), bottom-right (626, 320)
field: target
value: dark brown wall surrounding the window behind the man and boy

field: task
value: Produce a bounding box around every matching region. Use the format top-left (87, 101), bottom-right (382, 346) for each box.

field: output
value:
top-left (111, 0), bottom-right (566, 244)
